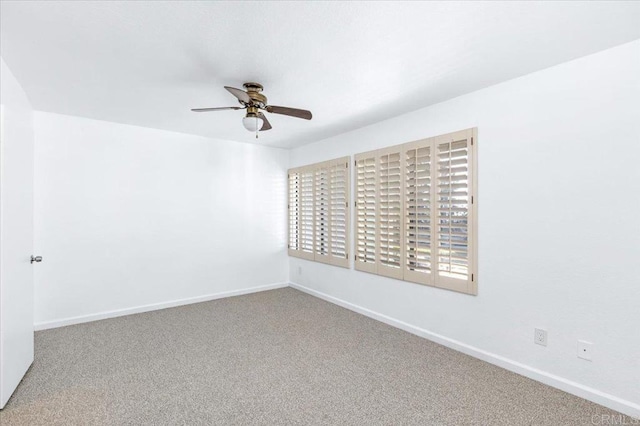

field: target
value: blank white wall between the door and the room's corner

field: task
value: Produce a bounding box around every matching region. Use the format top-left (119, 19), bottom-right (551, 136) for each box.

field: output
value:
top-left (35, 112), bottom-right (289, 328)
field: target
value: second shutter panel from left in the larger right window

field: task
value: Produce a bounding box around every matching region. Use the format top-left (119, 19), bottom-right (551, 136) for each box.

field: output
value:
top-left (377, 147), bottom-right (404, 279)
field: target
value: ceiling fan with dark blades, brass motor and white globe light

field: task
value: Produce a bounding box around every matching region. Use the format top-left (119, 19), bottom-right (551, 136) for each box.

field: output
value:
top-left (191, 82), bottom-right (311, 138)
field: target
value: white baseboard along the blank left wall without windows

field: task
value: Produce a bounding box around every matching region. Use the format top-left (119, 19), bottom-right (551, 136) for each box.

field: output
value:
top-left (34, 282), bottom-right (289, 331)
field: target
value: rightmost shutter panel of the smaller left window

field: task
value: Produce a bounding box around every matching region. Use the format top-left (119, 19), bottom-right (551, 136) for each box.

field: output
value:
top-left (329, 157), bottom-right (351, 267)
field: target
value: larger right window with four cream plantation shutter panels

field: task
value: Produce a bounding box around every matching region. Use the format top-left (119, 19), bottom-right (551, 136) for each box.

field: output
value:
top-left (355, 129), bottom-right (477, 294)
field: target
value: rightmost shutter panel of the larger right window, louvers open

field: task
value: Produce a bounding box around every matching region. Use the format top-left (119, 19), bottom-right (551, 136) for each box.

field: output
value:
top-left (435, 129), bottom-right (475, 292)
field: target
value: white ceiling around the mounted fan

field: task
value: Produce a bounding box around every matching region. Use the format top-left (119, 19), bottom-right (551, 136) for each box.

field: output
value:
top-left (0, 1), bottom-right (640, 147)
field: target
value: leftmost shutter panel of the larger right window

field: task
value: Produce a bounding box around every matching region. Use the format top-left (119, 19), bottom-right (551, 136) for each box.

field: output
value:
top-left (355, 152), bottom-right (378, 273)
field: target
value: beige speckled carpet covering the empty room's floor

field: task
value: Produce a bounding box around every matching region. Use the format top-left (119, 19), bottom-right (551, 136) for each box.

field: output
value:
top-left (0, 288), bottom-right (615, 426)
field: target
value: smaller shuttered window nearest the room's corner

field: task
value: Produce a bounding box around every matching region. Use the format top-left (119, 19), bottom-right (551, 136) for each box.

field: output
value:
top-left (288, 157), bottom-right (351, 267)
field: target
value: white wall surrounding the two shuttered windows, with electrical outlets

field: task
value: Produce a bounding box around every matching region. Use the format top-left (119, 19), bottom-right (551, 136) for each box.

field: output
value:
top-left (290, 41), bottom-right (640, 417)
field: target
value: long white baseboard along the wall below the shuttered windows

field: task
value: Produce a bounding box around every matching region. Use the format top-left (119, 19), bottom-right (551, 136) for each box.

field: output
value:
top-left (290, 282), bottom-right (640, 418)
